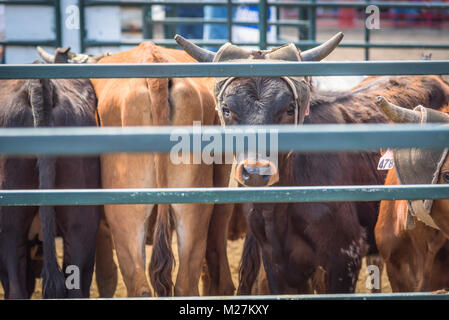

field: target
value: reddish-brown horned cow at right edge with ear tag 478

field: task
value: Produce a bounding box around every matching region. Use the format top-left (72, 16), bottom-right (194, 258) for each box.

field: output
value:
top-left (375, 99), bottom-right (449, 292)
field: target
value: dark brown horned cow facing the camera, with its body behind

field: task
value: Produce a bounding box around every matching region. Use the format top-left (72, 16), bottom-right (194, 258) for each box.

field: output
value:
top-left (176, 35), bottom-right (449, 294)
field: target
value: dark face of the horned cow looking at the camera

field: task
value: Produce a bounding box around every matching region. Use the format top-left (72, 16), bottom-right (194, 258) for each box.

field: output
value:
top-left (219, 77), bottom-right (310, 187)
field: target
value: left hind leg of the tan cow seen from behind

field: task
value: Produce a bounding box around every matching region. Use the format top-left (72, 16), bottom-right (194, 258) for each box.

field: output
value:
top-left (101, 154), bottom-right (155, 297)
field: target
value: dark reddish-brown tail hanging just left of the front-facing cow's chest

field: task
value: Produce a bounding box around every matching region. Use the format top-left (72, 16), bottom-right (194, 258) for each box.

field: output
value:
top-left (237, 229), bottom-right (261, 295)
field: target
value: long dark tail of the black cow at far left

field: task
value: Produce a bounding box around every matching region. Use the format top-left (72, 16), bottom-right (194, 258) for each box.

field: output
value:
top-left (28, 79), bottom-right (66, 298)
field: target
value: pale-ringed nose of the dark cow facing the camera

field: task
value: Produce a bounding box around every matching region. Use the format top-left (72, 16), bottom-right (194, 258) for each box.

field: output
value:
top-left (235, 160), bottom-right (279, 187)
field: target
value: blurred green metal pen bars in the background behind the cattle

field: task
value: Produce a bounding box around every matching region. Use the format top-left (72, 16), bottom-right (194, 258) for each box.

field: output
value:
top-left (0, 0), bottom-right (449, 60)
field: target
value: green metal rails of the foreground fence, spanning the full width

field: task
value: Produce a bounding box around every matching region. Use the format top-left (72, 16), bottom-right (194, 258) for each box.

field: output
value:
top-left (0, 61), bottom-right (449, 300)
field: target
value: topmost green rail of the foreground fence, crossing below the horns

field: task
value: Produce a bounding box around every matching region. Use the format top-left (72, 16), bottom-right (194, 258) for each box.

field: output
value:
top-left (0, 60), bottom-right (449, 79)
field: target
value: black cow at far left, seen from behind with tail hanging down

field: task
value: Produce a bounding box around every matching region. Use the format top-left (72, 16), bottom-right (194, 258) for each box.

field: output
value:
top-left (0, 62), bottom-right (101, 299)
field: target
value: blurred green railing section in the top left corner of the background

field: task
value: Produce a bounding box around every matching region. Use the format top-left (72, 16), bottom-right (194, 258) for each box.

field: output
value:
top-left (0, 0), bottom-right (62, 55)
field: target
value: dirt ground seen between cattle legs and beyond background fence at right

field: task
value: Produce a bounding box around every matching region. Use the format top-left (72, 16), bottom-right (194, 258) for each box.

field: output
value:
top-left (0, 28), bottom-right (449, 298)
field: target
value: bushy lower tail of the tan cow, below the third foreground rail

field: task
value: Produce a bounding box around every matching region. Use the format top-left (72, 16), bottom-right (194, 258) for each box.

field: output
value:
top-left (150, 204), bottom-right (175, 296)
